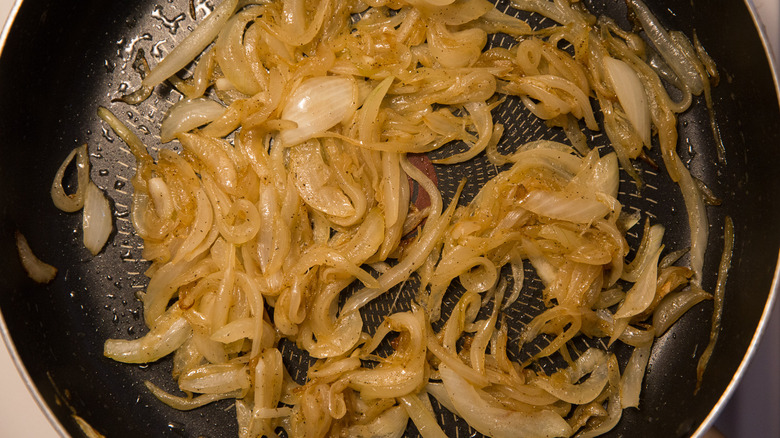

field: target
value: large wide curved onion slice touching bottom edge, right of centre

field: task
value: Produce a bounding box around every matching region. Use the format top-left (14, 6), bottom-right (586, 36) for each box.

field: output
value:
top-left (439, 364), bottom-right (572, 438)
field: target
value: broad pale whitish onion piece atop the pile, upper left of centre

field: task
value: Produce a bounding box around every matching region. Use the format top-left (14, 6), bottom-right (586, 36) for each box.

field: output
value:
top-left (280, 76), bottom-right (358, 146)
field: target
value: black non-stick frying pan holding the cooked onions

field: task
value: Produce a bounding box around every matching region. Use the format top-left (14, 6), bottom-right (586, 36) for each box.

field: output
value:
top-left (0, 0), bottom-right (780, 438)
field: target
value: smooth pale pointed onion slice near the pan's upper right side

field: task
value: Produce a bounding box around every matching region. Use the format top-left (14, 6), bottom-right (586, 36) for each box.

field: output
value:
top-left (604, 56), bottom-right (650, 147)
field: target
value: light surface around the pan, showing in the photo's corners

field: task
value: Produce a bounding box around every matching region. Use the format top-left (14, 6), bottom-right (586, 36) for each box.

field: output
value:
top-left (0, 0), bottom-right (780, 438)
